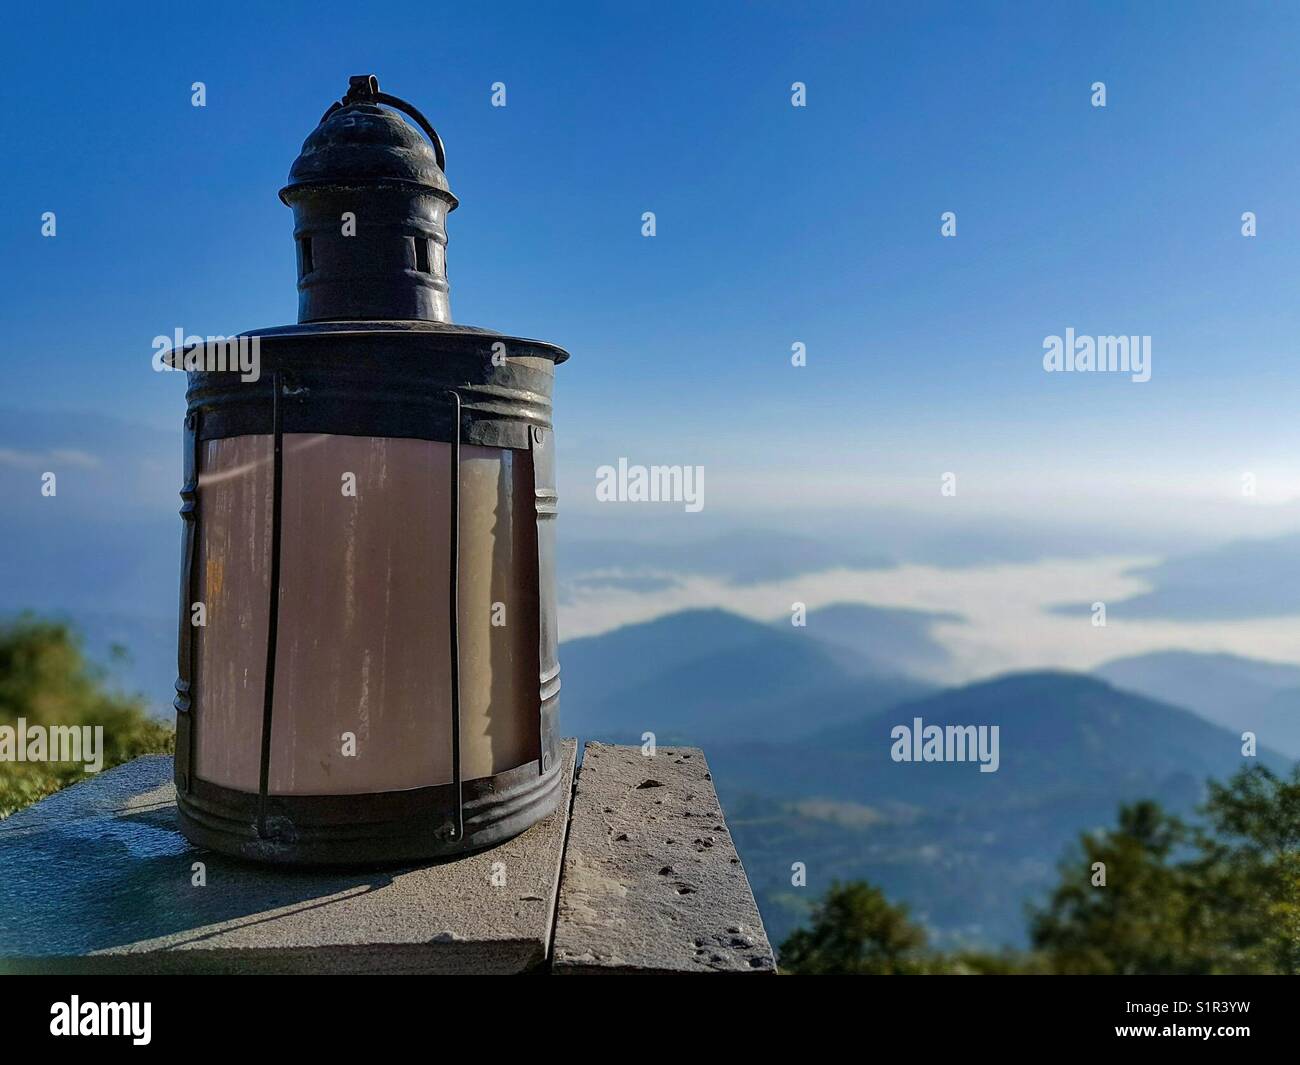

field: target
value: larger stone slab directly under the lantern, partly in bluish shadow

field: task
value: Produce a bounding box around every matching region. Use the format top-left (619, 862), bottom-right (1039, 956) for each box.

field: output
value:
top-left (0, 740), bottom-right (576, 973)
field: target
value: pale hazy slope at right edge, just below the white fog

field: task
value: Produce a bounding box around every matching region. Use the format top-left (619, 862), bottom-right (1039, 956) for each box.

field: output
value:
top-left (1093, 651), bottom-right (1300, 758)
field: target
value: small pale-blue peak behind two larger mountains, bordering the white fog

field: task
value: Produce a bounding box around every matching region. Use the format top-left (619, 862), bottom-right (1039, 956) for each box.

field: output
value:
top-left (774, 603), bottom-right (962, 681)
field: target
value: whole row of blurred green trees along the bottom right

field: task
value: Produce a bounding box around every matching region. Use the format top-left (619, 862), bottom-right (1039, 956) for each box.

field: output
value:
top-left (781, 766), bottom-right (1300, 974)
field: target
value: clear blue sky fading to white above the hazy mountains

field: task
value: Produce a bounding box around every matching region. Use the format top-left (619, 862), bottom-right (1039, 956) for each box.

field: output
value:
top-left (0, 3), bottom-right (1300, 525)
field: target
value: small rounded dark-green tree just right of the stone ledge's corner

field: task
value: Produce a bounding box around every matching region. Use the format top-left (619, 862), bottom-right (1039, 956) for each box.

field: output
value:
top-left (781, 882), bottom-right (930, 975)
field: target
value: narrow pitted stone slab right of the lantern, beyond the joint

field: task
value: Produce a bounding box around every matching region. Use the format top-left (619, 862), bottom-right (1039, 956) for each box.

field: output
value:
top-left (551, 743), bottom-right (776, 974)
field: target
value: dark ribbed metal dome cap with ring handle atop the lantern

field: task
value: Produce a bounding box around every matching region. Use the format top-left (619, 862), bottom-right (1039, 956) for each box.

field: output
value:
top-left (280, 74), bottom-right (456, 209)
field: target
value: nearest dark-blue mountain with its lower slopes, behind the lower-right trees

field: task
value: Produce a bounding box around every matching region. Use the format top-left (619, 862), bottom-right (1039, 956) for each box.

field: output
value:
top-left (706, 672), bottom-right (1287, 944)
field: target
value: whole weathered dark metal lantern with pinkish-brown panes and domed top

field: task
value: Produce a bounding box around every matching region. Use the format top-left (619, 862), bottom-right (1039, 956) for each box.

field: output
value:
top-left (169, 77), bottom-right (568, 863)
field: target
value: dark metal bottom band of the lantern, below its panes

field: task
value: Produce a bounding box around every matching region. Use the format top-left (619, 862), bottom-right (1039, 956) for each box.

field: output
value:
top-left (177, 758), bottom-right (564, 866)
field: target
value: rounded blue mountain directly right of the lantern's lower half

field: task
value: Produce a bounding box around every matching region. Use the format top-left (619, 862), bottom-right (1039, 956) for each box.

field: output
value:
top-left (560, 610), bottom-right (931, 744)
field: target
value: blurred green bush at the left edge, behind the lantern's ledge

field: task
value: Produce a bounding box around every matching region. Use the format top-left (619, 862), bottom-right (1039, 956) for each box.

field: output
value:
top-left (0, 614), bottom-right (174, 818)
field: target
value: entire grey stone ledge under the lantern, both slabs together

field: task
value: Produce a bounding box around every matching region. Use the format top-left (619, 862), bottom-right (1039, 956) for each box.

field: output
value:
top-left (0, 740), bottom-right (775, 974)
